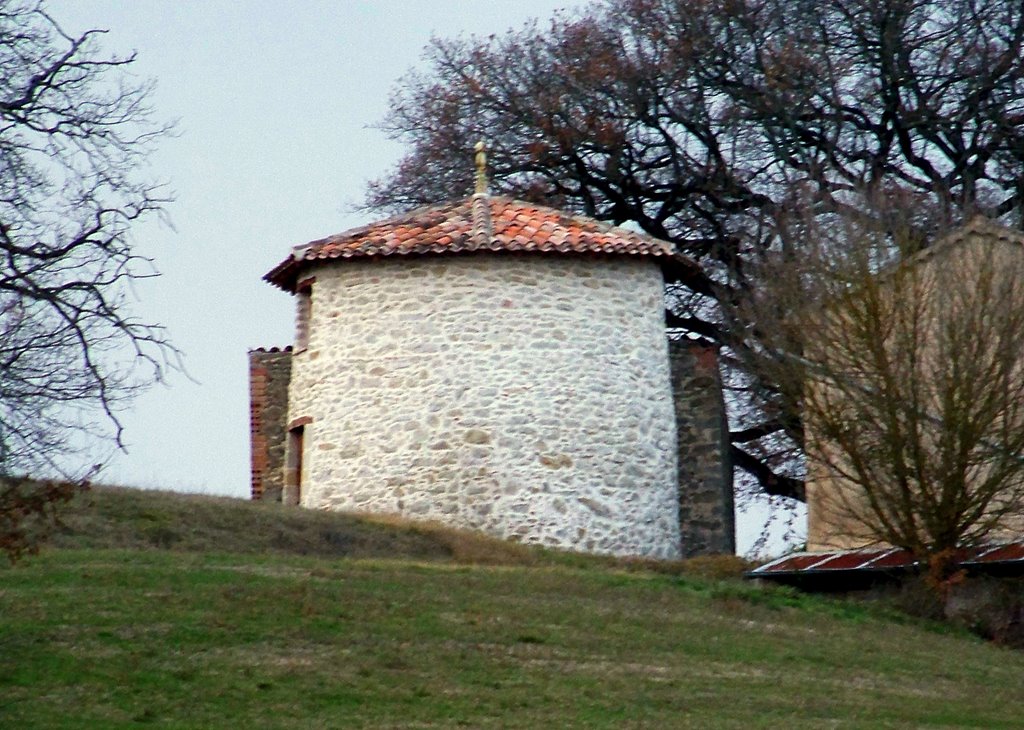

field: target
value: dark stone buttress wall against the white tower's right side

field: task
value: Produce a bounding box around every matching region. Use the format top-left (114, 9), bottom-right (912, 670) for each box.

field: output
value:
top-left (669, 340), bottom-right (736, 557)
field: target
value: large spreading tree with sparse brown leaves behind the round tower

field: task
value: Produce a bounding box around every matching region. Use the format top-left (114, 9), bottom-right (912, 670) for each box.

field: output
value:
top-left (368, 0), bottom-right (1024, 499)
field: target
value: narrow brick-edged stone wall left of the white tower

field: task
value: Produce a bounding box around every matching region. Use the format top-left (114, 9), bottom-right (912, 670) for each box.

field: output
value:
top-left (249, 347), bottom-right (292, 502)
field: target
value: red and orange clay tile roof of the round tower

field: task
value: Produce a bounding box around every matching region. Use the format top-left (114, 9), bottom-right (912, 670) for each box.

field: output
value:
top-left (263, 195), bottom-right (677, 291)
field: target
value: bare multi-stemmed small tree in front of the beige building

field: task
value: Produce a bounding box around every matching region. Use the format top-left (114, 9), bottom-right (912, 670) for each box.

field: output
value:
top-left (741, 201), bottom-right (1024, 572)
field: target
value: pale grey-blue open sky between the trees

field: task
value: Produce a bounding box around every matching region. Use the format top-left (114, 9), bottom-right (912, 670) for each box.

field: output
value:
top-left (49, 0), bottom-right (798, 548)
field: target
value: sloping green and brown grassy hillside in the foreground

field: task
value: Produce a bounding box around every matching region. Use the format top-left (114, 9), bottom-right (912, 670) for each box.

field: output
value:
top-left (0, 483), bottom-right (1024, 728)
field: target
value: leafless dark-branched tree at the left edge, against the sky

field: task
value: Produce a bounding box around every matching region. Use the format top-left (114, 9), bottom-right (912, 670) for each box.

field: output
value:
top-left (0, 0), bottom-right (173, 554)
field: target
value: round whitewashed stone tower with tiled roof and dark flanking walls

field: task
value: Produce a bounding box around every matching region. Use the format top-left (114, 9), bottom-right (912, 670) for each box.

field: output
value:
top-left (250, 185), bottom-right (734, 558)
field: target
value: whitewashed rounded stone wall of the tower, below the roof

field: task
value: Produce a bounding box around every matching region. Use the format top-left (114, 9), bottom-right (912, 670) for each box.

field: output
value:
top-left (289, 254), bottom-right (680, 558)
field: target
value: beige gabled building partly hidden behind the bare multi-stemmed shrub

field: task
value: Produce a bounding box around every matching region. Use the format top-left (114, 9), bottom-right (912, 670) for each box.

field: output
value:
top-left (804, 217), bottom-right (1024, 552)
